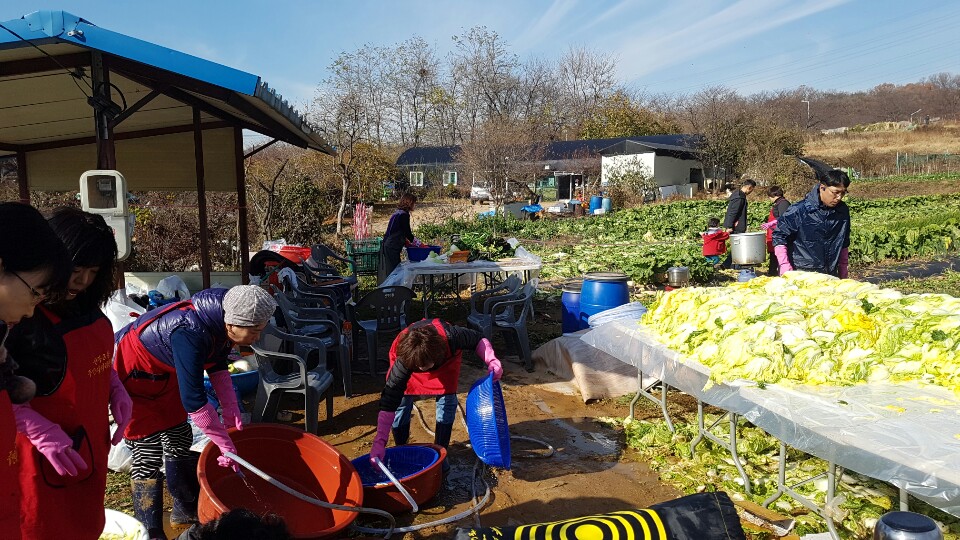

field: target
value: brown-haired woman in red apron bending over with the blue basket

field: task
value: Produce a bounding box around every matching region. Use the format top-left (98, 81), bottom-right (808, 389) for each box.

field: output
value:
top-left (370, 319), bottom-right (503, 469)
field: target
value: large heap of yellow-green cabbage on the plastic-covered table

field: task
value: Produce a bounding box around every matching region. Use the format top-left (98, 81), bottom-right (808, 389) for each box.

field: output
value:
top-left (642, 272), bottom-right (960, 392)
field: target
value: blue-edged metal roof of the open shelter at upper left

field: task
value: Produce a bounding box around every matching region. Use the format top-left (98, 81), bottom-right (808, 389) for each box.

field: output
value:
top-left (0, 11), bottom-right (333, 153)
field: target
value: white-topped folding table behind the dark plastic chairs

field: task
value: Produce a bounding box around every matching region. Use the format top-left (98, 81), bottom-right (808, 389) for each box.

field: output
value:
top-left (380, 257), bottom-right (542, 318)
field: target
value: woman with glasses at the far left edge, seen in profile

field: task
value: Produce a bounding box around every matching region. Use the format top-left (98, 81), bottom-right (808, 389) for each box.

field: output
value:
top-left (0, 203), bottom-right (71, 540)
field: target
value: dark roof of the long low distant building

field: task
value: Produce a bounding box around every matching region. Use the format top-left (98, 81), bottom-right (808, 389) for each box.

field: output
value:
top-left (397, 134), bottom-right (701, 166)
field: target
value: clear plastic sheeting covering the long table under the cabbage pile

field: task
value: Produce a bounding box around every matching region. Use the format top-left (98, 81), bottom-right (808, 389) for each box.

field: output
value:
top-left (581, 321), bottom-right (960, 516)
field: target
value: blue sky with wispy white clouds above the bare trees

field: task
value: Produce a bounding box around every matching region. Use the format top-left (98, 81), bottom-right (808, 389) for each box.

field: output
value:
top-left (0, 0), bottom-right (960, 107)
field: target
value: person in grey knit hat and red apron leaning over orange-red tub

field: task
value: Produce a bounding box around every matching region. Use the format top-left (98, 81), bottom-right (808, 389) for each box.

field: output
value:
top-left (114, 285), bottom-right (277, 539)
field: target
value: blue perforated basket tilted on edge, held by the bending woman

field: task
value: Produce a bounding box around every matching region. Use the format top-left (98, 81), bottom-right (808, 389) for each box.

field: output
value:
top-left (466, 375), bottom-right (510, 469)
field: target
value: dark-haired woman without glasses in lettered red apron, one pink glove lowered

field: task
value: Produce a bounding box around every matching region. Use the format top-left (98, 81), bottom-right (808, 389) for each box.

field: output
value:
top-left (7, 208), bottom-right (131, 540)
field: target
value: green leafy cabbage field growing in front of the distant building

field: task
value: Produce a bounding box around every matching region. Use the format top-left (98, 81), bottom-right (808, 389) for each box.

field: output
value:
top-left (417, 195), bottom-right (960, 283)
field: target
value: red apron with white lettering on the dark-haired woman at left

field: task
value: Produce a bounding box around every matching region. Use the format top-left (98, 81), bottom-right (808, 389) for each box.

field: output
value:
top-left (17, 306), bottom-right (113, 540)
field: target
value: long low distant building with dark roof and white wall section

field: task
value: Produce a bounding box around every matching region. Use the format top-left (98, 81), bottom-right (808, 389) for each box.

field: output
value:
top-left (397, 135), bottom-right (703, 200)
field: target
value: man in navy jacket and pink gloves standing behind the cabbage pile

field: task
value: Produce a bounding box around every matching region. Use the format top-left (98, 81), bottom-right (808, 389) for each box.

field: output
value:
top-left (773, 169), bottom-right (850, 278)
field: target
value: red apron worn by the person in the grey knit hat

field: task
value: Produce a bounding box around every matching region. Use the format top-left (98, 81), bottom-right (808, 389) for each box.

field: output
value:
top-left (114, 301), bottom-right (215, 441)
